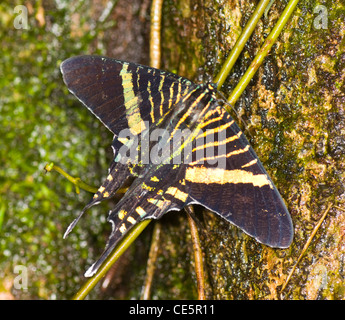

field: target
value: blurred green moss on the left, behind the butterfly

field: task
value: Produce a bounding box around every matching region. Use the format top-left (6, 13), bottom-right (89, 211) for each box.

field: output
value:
top-left (0, 1), bottom-right (111, 298)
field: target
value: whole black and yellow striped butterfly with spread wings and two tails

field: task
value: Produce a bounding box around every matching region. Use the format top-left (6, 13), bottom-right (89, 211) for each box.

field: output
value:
top-left (61, 56), bottom-right (293, 276)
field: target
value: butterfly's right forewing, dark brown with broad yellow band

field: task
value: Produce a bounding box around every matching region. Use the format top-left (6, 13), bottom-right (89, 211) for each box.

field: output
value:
top-left (185, 107), bottom-right (293, 248)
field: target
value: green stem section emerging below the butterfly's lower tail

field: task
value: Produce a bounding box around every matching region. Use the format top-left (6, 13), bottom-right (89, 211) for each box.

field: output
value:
top-left (73, 220), bottom-right (151, 300)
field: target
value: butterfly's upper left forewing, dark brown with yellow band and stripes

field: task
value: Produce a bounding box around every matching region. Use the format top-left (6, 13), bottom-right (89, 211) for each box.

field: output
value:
top-left (61, 56), bottom-right (192, 135)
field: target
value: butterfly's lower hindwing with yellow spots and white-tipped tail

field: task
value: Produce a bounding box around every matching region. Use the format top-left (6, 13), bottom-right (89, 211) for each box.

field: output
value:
top-left (85, 164), bottom-right (188, 277)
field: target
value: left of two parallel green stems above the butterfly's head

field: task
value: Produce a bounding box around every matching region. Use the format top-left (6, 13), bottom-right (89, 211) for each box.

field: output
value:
top-left (214, 0), bottom-right (270, 90)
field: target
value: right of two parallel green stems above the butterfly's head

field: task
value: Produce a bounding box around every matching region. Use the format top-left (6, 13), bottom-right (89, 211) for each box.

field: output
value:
top-left (228, 0), bottom-right (298, 105)
